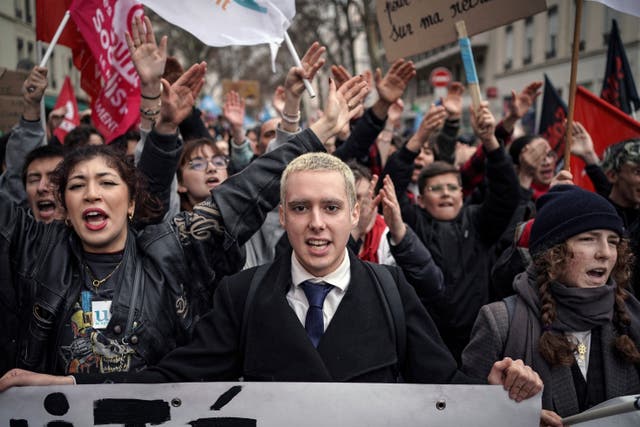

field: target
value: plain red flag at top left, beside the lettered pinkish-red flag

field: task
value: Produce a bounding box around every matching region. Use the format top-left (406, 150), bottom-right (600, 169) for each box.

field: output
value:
top-left (36, 0), bottom-right (80, 49)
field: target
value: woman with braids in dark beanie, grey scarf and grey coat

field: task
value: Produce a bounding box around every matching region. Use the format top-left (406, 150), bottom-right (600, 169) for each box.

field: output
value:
top-left (462, 185), bottom-right (640, 426)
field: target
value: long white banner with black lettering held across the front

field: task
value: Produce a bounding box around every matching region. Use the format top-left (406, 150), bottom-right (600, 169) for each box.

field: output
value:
top-left (0, 383), bottom-right (541, 427)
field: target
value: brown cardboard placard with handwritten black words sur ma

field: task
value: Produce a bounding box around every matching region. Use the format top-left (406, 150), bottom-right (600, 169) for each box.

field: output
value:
top-left (376, 0), bottom-right (547, 61)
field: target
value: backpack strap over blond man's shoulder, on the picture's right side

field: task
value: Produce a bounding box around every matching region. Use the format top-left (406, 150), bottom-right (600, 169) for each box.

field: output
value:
top-left (364, 262), bottom-right (407, 368)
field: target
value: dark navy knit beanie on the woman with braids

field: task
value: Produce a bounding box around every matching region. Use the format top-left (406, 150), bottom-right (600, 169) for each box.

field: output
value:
top-left (529, 185), bottom-right (624, 256)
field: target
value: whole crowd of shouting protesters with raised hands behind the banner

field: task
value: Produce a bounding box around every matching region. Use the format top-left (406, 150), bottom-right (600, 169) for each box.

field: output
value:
top-left (0, 14), bottom-right (640, 426)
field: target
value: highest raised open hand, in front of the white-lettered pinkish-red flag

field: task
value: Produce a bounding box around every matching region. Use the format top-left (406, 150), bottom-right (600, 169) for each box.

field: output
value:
top-left (125, 16), bottom-right (167, 93)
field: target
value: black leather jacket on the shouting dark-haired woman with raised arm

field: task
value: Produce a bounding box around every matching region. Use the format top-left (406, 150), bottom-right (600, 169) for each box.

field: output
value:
top-left (0, 130), bottom-right (324, 374)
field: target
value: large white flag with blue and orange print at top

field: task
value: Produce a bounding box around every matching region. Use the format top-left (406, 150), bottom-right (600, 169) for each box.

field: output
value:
top-left (141, 0), bottom-right (296, 46)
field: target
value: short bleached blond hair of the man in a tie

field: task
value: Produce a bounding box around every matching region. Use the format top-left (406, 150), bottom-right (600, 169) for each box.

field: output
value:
top-left (280, 153), bottom-right (357, 209)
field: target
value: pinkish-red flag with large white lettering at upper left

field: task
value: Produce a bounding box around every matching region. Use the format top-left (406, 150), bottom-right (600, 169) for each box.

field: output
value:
top-left (70, 0), bottom-right (143, 143)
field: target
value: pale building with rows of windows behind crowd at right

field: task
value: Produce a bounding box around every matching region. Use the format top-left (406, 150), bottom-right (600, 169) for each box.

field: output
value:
top-left (409, 0), bottom-right (640, 131)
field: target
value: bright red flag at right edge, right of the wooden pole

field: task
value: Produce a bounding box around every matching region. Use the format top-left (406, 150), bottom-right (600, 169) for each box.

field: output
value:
top-left (571, 86), bottom-right (640, 190)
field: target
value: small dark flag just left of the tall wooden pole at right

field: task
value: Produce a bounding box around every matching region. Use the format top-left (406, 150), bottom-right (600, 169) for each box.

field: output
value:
top-left (538, 74), bottom-right (567, 158)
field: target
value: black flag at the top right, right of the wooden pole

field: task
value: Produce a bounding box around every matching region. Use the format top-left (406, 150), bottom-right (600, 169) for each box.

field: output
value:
top-left (600, 19), bottom-right (640, 114)
